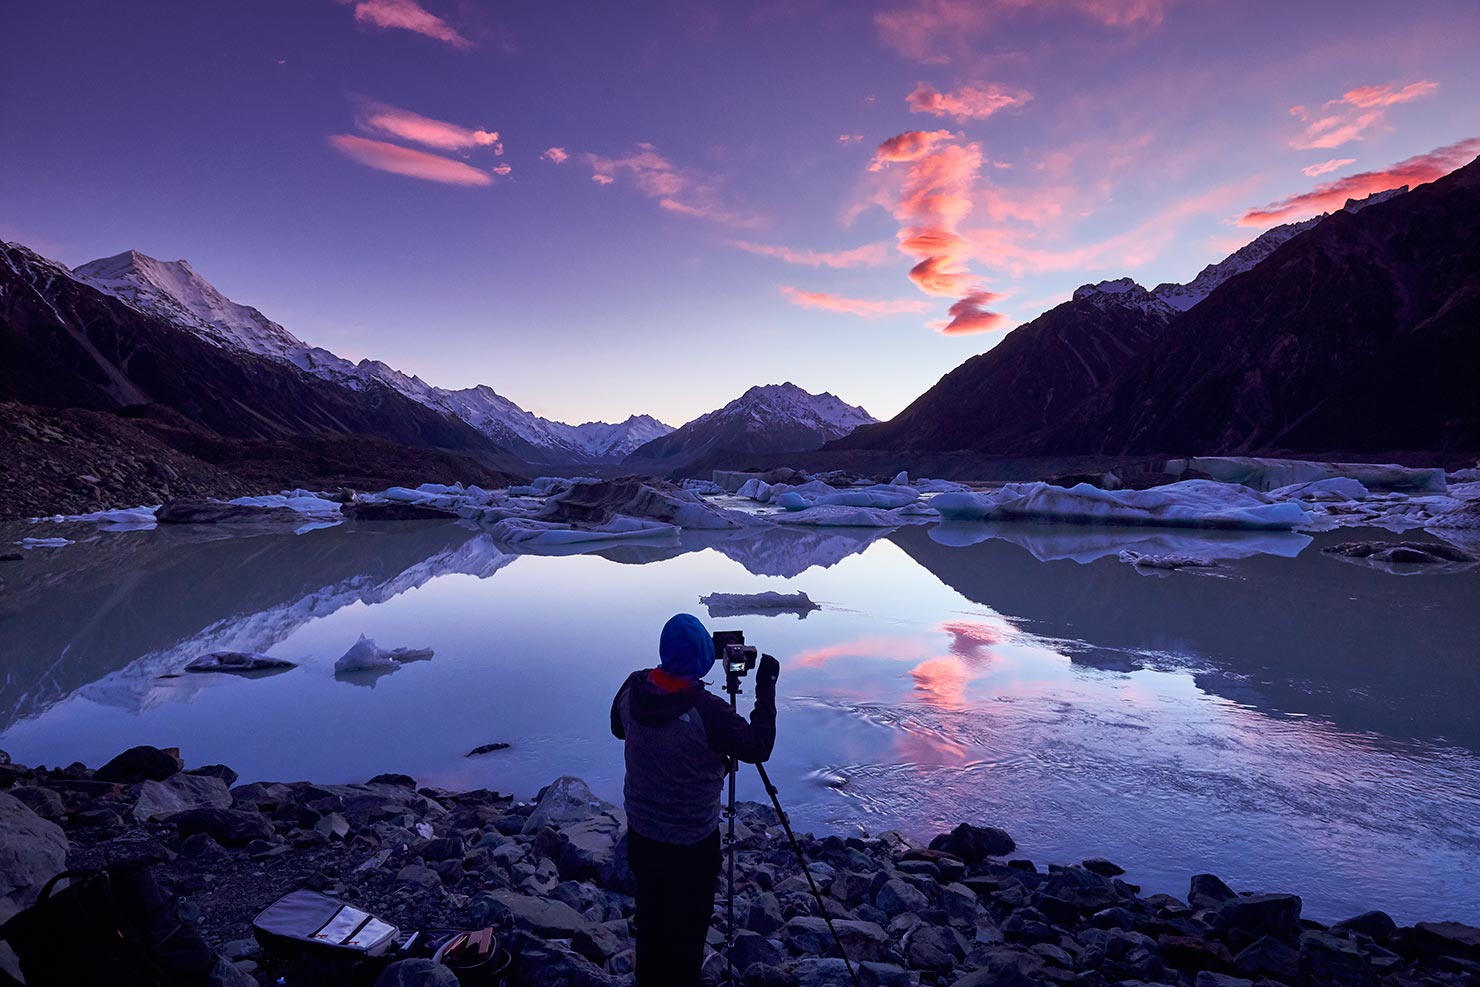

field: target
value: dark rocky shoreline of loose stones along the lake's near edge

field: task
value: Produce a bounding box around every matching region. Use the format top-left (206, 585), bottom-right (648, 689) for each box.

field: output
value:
top-left (0, 747), bottom-right (1480, 987)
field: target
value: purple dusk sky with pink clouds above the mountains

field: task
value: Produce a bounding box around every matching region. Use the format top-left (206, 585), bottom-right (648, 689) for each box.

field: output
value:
top-left (0, 0), bottom-right (1480, 423)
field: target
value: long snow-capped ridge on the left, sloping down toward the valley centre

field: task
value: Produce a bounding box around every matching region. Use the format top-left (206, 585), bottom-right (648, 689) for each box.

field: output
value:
top-left (73, 250), bottom-right (673, 465)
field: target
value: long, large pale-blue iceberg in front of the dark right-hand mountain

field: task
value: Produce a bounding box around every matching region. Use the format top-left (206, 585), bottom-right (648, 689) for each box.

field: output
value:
top-left (931, 479), bottom-right (1313, 531)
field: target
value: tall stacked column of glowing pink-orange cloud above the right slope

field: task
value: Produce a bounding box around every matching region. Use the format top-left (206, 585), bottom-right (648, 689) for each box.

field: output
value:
top-left (869, 130), bottom-right (1000, 333)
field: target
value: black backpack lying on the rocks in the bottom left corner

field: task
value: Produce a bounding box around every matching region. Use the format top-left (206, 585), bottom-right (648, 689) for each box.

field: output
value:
top-left (0, 861), bottom-right (216, 987)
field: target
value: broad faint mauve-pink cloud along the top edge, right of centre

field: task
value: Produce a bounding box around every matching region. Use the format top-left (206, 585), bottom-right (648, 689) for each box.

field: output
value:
top-left (873, 0), bottom-right (1171, 65)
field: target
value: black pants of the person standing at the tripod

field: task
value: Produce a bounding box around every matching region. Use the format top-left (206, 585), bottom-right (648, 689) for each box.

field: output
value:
top-left (628, 829), bottom-right (721, 987)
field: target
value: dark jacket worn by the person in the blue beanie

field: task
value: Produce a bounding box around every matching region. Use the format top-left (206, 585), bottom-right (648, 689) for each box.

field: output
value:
top-left (611, 669), bottom-right (776, 843)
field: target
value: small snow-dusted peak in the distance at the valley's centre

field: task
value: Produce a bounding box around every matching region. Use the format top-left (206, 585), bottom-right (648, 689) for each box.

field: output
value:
top-left (626, 382), bottom-right (876, 466)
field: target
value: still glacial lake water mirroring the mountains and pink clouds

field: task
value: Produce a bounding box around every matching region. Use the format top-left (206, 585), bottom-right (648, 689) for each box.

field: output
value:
top-left (0, 522), bottom-right (1480, 923)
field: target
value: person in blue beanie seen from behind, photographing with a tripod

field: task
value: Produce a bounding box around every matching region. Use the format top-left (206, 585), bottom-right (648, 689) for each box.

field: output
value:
top-left (611, 614), bottom-right (781, 987)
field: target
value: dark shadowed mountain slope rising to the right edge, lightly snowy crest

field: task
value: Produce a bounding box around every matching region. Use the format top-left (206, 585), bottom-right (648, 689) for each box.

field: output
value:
top-left (826, 161), bottom-right (1480, 457)
